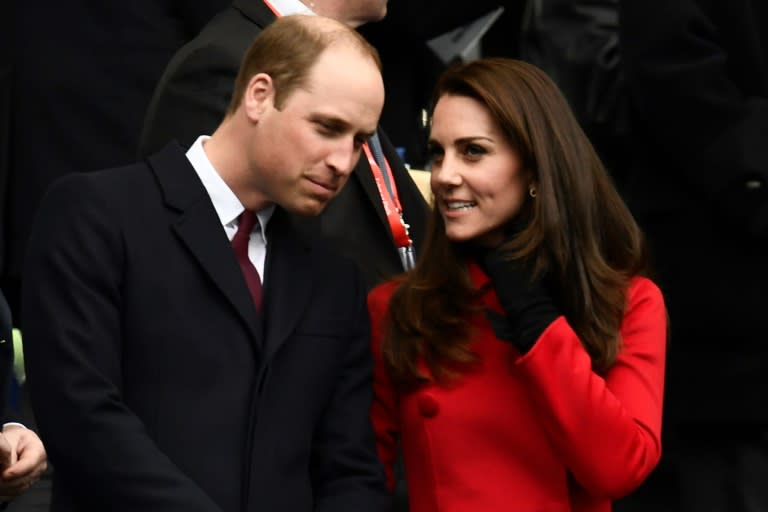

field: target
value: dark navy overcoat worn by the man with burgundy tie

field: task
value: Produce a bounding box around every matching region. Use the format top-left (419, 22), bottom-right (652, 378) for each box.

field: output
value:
top-left (22, 144), bottom-right (387, 512)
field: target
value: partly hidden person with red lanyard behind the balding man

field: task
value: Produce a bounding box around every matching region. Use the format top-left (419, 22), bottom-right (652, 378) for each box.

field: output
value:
top-left (139, 0), bottom-right (428, 288)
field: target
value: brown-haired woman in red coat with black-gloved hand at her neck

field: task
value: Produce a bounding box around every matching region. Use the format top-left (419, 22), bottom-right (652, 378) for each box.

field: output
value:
top-left (369, 59), bottom-right (666, 512)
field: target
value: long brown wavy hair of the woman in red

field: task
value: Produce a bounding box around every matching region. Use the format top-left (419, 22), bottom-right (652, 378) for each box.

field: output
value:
top-left (382, 58), bottom-right (647, 386)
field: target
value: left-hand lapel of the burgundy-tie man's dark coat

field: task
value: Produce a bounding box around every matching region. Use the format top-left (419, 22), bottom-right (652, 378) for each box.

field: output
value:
top-left (149, 144), bottom-right (262, 346)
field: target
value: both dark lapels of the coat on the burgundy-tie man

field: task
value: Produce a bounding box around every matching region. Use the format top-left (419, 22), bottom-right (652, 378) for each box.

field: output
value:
top-left (148, 143), bottom-right (322, 361)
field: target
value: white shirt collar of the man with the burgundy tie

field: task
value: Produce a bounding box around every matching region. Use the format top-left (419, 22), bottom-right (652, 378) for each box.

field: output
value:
top-left (187, 135), bottom-right (275, 242)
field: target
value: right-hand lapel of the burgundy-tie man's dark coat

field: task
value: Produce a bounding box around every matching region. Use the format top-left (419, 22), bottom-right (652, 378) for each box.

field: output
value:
top-left (264, 207), bottom-right (314, 362)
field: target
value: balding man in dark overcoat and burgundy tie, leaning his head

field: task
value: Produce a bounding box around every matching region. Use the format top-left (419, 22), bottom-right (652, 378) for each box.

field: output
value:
top-left (22, 16), bottom-right (388, 512)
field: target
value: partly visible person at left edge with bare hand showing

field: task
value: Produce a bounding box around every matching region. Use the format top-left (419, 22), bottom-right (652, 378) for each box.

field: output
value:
top-left (0, 291), bottom-right (47, 507)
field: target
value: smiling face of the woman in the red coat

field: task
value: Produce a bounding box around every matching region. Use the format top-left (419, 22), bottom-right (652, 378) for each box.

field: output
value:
top-left (429, 94), bottom-right (528, 246)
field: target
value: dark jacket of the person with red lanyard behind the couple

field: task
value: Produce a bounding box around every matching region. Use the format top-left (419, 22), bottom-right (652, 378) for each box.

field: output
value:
top-left (139, 0), bottom-right (428, 288)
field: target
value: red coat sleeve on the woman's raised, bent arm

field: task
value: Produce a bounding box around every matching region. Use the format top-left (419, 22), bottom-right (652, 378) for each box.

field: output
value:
top-left (517, 278), bottom-right (667, 499)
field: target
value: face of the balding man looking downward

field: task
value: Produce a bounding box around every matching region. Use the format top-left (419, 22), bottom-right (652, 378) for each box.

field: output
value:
top-left (249, 43), bottom-right (384, 215)
